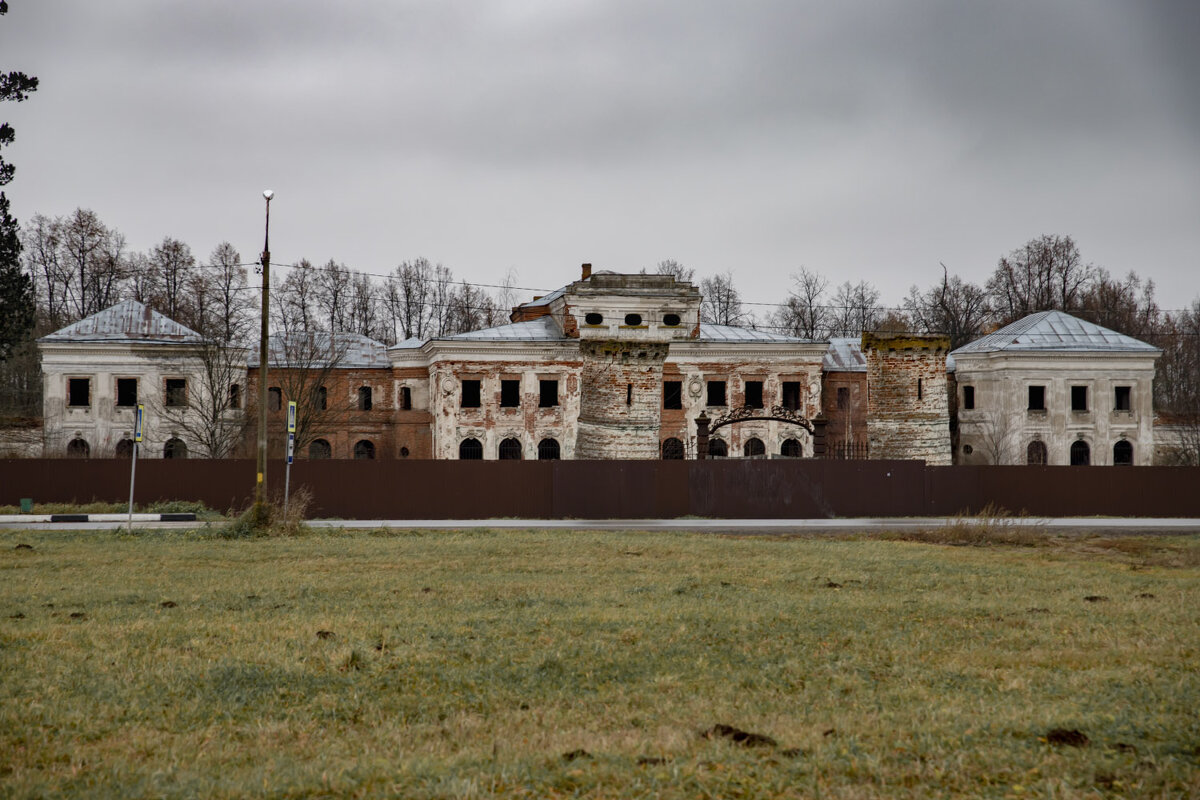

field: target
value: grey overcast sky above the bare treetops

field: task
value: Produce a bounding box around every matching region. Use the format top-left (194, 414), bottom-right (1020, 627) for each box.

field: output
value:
top-left (0, 0), bottom-right (1200, 308)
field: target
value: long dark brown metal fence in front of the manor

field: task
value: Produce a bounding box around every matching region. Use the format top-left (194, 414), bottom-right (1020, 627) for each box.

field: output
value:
top-left (0, 458), bottom-right (1200, 519)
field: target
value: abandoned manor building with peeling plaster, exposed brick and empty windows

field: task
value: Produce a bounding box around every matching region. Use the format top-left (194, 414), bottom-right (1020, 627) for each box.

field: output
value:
top-left (38, 264), bottom-right (1158, 465)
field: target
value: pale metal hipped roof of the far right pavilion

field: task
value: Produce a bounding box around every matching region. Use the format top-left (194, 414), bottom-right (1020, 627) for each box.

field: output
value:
top-left (954, 311), bottom-right (1159, 354)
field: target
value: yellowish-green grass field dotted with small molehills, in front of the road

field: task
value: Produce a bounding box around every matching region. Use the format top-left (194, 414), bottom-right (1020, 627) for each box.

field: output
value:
top-left (0, 531), bottom-right (1200, 798)
